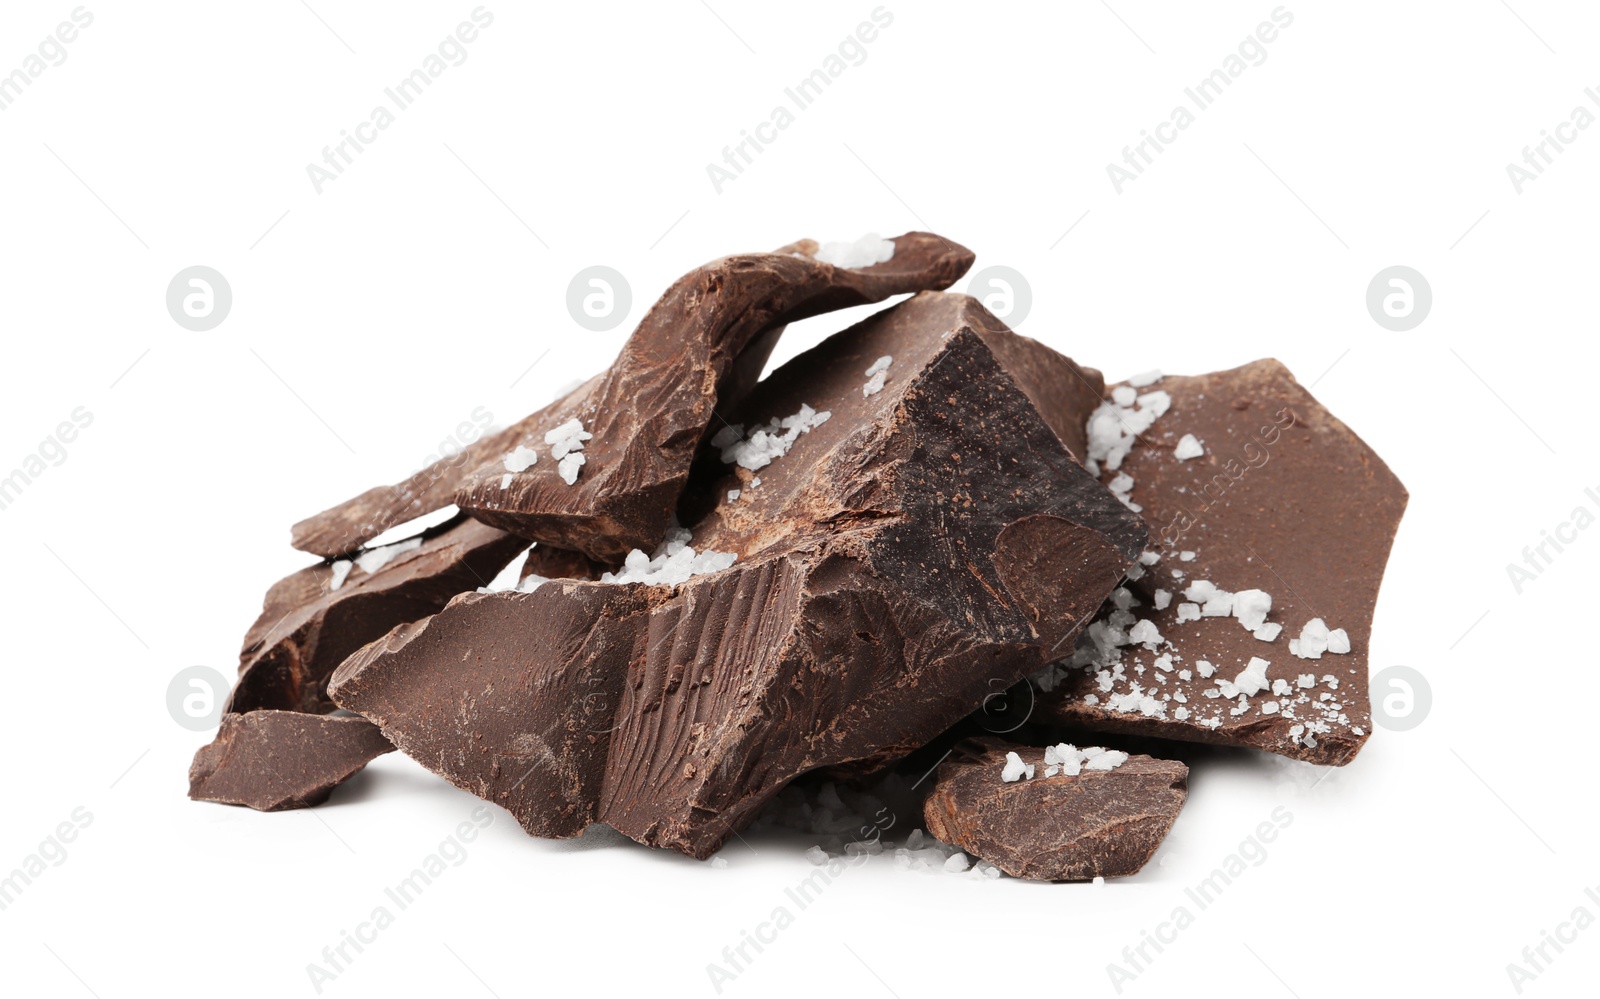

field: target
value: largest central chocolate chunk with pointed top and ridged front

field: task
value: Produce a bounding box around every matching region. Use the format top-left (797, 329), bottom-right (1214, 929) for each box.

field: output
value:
top-left (333, 295), bottom-right (1146, 857)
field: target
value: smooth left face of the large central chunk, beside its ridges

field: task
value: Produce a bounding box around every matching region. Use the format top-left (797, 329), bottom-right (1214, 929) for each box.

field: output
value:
top-left (330, 581), bottom-right (667, 839)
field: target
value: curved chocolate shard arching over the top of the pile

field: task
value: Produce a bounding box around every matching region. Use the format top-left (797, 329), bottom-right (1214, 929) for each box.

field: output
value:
top-left (456, 232), bottom-right (973, 559)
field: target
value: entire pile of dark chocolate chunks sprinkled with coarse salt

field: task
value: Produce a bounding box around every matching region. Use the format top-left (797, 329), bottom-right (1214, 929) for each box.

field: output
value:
top-left (190, 232), bottom-right (1406, 881)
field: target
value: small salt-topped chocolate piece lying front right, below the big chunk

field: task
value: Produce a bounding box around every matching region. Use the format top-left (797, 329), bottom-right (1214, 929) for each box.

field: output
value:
top-left (923, 738), bottom-right (1189, 881)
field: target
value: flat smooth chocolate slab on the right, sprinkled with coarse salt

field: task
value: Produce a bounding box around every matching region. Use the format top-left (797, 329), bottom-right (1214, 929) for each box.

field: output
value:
top-left (1034, 360), bottom-right (1406, 765)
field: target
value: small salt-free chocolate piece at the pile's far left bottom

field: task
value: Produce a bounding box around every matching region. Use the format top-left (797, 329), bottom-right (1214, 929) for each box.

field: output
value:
top-left (189, 711), bottom-right (394, 812)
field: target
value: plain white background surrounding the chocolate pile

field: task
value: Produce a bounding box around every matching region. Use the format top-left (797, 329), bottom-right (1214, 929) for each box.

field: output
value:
top-left (0, 0), bottom-right (1600, 999)
